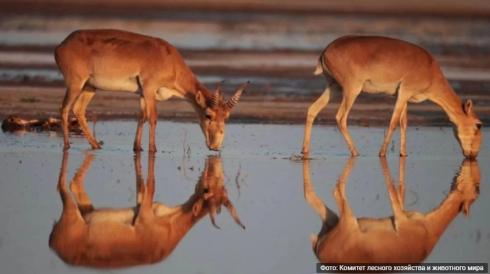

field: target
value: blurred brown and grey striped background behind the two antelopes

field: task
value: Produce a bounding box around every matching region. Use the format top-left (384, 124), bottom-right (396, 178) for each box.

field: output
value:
top-left (0, 0), bottom-right (490, 126)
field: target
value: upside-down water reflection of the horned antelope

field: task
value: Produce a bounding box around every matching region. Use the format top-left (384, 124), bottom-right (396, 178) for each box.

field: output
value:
top-left (49, 152), bottom-right (245, 268)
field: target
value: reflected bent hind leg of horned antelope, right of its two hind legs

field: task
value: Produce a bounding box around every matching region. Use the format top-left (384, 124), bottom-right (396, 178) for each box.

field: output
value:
top-left (70, 154), bottom-right (95, 215)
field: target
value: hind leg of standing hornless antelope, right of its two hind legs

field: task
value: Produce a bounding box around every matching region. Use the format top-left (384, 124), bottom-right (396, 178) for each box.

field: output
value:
top-left (335, 85), bottom-right (362, 156)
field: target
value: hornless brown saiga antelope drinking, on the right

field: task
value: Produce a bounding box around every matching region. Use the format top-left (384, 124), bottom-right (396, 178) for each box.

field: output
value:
top-left (302, 35), bottom-right (482, 158)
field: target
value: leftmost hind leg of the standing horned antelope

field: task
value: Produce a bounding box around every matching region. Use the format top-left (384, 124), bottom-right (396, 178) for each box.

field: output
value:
top-left (60, 80), bottom-right (85, 150)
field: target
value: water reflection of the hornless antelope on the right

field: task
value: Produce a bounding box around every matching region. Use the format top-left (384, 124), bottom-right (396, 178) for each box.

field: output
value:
top-left (303, 157), bottom-right (480, 263)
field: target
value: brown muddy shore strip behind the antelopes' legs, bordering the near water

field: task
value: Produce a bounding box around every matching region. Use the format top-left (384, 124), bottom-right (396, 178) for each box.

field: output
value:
top-left (0, 86), bottom-right (490, 127)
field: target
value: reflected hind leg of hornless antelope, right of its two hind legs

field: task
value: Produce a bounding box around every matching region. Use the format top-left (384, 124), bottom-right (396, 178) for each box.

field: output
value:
top-left (334, 157), bottom-right (358, 230)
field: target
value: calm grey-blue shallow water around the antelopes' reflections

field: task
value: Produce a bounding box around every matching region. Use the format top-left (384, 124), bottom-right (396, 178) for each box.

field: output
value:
top-left (0, 121), bottom-right (490, 274)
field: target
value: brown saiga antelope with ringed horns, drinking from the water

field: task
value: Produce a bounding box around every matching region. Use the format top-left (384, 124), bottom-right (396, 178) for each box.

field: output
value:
top-left (55, 29), bottom-right (248, 152)
